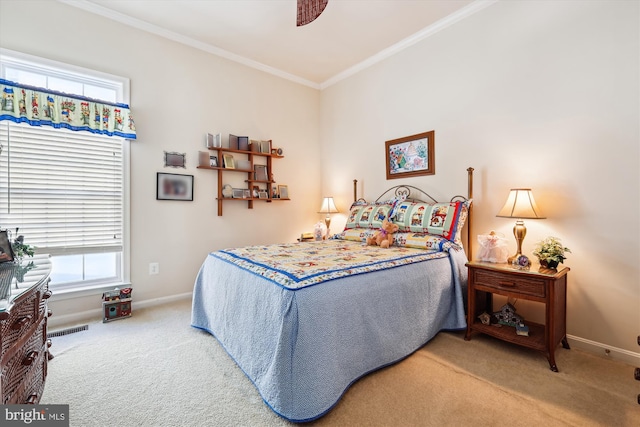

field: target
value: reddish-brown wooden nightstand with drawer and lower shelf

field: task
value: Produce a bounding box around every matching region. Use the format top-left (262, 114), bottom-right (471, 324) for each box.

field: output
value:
top-left (465, 261), bottom-right (570, 372)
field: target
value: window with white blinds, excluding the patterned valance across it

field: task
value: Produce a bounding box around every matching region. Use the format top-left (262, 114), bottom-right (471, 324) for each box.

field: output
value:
top-left (0, 50), bottom-right (128, 290)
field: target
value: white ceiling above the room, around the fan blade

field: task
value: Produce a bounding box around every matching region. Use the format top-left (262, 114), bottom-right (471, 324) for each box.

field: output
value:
top-left (59, 0), bottom-right (495, 88)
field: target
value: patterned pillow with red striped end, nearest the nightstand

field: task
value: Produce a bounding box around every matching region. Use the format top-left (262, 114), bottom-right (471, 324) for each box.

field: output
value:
top-left (393, 201), bottom-right (463, 241)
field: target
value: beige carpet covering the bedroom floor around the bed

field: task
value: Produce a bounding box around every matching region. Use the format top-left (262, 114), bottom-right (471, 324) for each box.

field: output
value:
top-left (41, 301), bottom-right (640, 427)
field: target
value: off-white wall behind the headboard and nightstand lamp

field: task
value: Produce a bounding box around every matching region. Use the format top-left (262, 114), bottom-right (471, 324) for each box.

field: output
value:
top-left (321, 1), bottom-right (640, 360)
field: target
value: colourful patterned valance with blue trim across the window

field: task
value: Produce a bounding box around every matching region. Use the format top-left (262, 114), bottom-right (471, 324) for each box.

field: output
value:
top-left (0, 79), bottom-right (136, 139)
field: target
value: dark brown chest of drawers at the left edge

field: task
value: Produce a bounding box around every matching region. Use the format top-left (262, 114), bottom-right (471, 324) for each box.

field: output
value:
top-left (0, 255), bottom-right (51, 405)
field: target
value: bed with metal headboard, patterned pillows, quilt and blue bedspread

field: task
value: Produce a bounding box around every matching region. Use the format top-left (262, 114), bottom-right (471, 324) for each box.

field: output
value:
top-left (191, 168), bottom-right (473, 422)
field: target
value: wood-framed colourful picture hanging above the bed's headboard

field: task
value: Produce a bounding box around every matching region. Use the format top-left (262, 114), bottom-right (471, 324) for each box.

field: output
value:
top-left (385, 131), bottom-right (436, 179)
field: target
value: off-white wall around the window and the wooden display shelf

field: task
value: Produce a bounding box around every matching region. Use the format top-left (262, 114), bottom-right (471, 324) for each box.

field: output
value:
top-left (0, 1), bottom-right (321, 324)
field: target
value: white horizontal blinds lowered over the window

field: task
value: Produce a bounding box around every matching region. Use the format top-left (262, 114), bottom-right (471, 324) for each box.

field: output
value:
top-left (0, 121), bottom-right (123, 255)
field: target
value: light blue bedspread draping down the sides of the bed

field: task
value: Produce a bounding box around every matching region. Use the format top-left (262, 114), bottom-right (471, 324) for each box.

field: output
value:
top-left (192, 241), bottom-right (467, 422)
